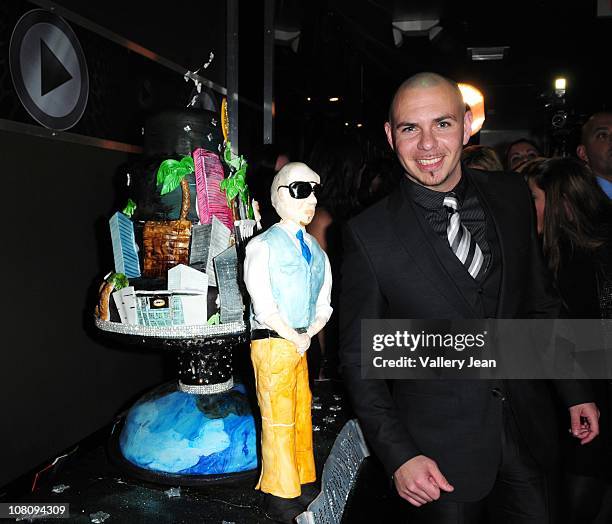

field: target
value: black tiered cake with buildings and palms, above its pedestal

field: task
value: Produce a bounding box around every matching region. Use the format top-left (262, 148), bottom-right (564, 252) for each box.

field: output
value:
top-left (97, 106), bottom-right (252, 334)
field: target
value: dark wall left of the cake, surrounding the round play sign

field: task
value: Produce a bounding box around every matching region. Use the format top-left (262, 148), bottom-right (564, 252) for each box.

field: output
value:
top-left (0, 0), bottom-right (235, 487)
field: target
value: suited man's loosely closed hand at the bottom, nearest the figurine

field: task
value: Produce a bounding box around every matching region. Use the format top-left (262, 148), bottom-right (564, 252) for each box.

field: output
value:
top-left (393, 455), bottom-right (455, 507)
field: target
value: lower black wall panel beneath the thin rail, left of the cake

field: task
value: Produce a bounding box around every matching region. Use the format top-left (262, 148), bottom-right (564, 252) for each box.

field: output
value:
top-left (0, 131), bottom-right (162, 486)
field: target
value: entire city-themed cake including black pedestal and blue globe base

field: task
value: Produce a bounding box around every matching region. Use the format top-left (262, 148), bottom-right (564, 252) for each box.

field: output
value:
top-left (95, 102), bottom-right (257, 485)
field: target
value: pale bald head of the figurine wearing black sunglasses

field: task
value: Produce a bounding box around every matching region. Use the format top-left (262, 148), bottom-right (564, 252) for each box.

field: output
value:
top-left (271, 162), bottom-right (320, 226)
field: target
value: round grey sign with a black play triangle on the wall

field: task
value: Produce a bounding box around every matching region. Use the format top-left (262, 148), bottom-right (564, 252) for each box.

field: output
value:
top-left (9, 9), bottom-right (89, 131)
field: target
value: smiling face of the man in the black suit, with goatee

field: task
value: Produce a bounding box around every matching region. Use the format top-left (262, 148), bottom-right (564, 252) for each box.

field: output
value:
top-left (385, 82), bottom-right (472, 192)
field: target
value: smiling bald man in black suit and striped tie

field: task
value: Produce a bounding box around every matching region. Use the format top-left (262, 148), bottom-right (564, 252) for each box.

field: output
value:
top-left (340, 73), bottom-right (598, 524)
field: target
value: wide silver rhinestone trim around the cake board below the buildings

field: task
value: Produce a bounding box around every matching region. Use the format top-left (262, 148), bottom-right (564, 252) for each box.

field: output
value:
top-left (95, 318), bottom-right (246, 338)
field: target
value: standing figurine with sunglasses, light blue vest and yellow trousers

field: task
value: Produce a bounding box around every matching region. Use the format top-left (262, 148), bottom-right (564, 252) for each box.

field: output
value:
top-left (244, 162), bottom-right (332, 522)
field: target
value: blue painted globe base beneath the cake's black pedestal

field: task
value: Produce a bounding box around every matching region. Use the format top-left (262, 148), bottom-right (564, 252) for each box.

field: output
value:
top-left (109, 382), bottom-right (258, 486)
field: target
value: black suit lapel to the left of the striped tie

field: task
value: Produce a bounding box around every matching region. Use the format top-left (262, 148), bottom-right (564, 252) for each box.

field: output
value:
top-left (388, 184), bottom-right (478, 318)
